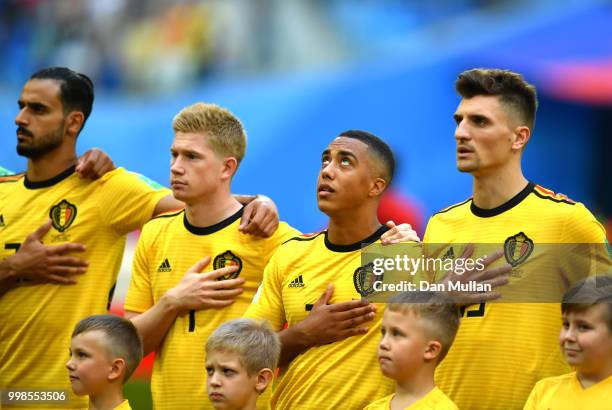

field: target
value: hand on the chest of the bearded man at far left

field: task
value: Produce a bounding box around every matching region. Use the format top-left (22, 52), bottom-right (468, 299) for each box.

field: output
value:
top-left (6, 220), bottom-right (88, 285)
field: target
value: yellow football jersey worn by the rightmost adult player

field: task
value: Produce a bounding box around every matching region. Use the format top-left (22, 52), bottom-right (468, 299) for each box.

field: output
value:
top-left (424, 183), bottom-right (610, 410)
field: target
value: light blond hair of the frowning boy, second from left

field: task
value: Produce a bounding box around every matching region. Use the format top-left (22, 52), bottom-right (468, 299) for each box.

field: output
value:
top-left (206, 318), bottom-right (281, 375)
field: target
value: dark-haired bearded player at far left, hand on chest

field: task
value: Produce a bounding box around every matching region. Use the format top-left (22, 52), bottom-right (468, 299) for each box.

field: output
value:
top-left (0, 67), bottom-right (275, 408)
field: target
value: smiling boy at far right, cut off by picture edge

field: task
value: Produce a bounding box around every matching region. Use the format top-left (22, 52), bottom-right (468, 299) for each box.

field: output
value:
top-left (525, 276), bottom-right (612, 410)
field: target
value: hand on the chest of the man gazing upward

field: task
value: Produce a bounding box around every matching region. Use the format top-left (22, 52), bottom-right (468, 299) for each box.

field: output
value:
top-left (294, 284), bottom-right (376, 346)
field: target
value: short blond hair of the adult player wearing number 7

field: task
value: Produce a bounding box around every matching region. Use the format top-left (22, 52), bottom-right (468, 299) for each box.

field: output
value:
top-left (172, 102), bottom-right (246, 164)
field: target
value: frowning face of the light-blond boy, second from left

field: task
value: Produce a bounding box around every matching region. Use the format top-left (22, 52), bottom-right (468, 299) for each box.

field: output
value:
top-left (206, 351), bottom-right (258, 410)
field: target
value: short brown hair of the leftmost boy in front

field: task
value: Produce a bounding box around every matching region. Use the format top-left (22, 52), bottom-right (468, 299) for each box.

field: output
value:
top-left (72, 315), bottom-right (143, 383)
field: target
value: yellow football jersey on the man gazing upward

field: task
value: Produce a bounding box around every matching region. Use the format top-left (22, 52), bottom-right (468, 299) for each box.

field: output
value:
top-left (246, 227), bottom-right (394, 410)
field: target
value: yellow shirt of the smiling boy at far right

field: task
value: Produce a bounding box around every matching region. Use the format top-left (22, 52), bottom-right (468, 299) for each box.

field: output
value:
top-left (524, 372), bottom-right (612, 410)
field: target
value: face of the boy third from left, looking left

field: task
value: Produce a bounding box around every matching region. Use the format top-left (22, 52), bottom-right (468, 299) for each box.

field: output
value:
top-left (378, 309), bottom-right (429, 380)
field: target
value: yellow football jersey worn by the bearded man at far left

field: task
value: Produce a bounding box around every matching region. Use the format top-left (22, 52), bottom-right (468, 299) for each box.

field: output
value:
top-left (0, 167), bottom-right (169, 408)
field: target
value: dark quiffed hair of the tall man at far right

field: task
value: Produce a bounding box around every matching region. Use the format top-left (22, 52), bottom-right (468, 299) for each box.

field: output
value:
top-left (455, 68), bottom-right (538, 129)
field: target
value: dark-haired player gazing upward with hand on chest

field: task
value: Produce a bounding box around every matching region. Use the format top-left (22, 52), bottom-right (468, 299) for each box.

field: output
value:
top-left (246, 131), bottom-right (418, 409)
